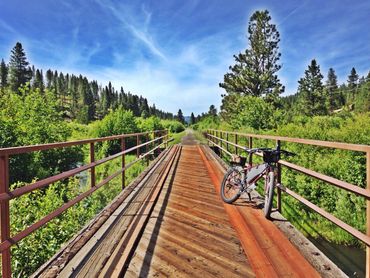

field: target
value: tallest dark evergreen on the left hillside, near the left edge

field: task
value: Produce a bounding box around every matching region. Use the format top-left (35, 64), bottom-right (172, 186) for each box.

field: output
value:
top-left (8, 42), bottom-right (32, 92)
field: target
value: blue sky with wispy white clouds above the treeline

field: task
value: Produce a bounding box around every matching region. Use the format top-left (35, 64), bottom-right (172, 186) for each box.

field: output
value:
top-left (0, 0), bottom-right (370, 115)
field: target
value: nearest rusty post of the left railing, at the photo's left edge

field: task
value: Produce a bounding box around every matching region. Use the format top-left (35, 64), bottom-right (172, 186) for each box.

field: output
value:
top-left (0, 155), bottom-right (12, 278)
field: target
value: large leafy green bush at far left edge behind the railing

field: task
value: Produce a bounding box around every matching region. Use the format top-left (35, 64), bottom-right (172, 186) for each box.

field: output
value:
top-left (0, 86), bottom-right (82, 182)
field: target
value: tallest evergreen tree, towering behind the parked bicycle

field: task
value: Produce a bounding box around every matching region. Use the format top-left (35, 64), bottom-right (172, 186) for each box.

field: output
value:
top-left (219, 10), bottom-right (284, 112)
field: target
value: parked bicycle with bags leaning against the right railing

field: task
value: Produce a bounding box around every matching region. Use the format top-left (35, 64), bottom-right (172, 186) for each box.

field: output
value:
top-left (221, 147), bottom-right (295, 218)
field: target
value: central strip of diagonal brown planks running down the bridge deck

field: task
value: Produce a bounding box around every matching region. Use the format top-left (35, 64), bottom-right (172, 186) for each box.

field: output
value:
top-left (125, 145), bottom-right (254, 277)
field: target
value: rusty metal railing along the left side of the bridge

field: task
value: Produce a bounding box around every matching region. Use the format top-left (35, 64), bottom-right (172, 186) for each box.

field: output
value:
top-left (0, 130), bottom-right (170, 278)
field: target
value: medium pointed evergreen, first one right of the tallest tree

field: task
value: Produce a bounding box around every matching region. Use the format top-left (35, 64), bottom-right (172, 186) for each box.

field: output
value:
top-left (298, 59), bottom-right (326, 116)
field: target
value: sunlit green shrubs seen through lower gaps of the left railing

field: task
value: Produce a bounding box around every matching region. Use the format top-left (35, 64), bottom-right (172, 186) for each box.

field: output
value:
top-left (10, 156), bottom-right (145, 277)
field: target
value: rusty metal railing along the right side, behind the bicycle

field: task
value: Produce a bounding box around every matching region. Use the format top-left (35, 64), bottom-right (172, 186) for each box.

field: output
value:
top-left (205, 129), bottom-right (370, 277)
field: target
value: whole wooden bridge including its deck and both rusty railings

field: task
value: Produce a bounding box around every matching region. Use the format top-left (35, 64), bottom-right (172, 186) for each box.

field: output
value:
top-left (0, 131), bottom-right (370, 277)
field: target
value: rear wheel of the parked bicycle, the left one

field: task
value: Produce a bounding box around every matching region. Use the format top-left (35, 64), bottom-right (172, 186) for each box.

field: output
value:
top-left (220, 166), bottom-right (243, 204)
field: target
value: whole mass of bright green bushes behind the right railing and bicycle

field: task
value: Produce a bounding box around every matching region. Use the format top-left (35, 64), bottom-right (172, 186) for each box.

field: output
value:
top-left (194, 108), bottom-right (370, 245)
